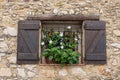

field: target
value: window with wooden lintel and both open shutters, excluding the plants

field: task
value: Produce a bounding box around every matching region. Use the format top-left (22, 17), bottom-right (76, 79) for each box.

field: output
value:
top-left (17, 16), bottom-right (106, 64)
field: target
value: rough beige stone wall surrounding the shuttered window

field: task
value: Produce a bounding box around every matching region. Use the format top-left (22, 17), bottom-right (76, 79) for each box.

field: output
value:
top-left (0, 0), bottom-right (120, 80)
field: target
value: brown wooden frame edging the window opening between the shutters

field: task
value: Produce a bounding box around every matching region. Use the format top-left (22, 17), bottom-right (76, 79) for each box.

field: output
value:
top-left (39, 20), bottom-right (83, 65)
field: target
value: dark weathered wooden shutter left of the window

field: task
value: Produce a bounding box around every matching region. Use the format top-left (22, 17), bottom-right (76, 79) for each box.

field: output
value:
top-left (17, 20), bottom-right (40, 64)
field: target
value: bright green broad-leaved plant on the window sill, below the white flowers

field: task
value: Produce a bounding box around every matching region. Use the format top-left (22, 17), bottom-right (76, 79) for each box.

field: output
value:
top-left (43, 48), bottom-right (80, 64)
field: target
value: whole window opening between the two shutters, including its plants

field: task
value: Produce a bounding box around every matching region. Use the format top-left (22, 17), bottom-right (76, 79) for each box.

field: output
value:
top-left (41, 21), bottom-right (82, 64)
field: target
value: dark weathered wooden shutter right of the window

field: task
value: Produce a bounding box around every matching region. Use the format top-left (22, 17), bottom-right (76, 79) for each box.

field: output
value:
top-left (84, 21), bottom-right (106, 64)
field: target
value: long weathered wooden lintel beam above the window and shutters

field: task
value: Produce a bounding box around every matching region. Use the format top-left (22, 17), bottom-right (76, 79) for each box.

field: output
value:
top-left (27, 15), bottom-right (99, 21)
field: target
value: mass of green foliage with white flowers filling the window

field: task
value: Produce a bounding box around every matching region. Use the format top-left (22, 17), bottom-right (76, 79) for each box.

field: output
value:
top-left (42, 30), bottom-right (80, 65)
